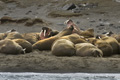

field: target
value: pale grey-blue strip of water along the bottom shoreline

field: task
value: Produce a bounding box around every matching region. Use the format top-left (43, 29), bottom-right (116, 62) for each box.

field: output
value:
top-left (0, 72), bottom-right (120, 80)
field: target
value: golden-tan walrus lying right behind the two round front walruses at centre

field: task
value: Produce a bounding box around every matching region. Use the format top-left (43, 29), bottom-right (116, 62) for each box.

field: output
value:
top-left (60, 33), bottom-right (87, 44)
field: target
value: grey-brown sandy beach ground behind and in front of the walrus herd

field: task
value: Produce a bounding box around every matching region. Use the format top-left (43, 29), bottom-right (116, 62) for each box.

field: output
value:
top-left (0, 0), bottom-right (120, 73)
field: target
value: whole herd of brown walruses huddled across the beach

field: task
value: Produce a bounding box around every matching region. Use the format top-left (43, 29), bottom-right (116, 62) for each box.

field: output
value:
top-left (0, 20), bottom-right (120, 57)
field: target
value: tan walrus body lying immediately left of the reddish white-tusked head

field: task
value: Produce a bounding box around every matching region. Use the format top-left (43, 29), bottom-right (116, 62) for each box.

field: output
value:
top-left (22, 32), bottom-right (40, 44)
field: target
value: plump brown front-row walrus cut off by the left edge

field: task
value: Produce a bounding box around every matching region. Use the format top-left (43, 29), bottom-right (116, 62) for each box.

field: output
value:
top-left (0, 39), bottom-right (25, 55)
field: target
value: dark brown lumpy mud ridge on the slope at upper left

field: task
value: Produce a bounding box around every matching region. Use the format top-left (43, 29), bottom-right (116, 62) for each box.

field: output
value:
top-left (0, 16), bottom-right (50, 26)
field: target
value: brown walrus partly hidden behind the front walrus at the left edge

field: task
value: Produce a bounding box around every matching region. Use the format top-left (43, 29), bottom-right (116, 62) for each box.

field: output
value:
top-left (13, 39), bottom-right (32, 53)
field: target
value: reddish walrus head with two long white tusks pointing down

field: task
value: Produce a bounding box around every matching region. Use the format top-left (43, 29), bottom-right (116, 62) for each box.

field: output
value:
top-left (40, 27), bottom-right (52, 39)
